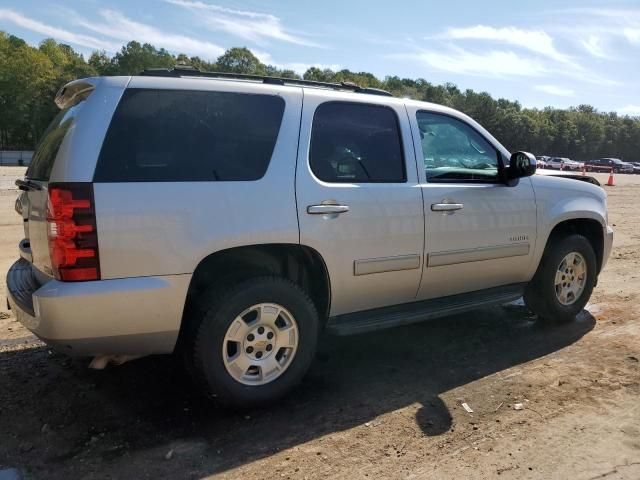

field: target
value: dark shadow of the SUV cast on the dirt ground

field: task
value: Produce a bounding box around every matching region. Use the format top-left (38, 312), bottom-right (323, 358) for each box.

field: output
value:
top-left (0, 305), bottom-right (595, 478)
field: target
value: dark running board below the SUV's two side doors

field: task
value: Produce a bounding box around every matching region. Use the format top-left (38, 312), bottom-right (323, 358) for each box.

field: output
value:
top-left (327, 283), bottom-right (527, 335)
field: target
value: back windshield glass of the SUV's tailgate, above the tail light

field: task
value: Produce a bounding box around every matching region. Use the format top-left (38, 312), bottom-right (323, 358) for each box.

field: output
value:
top-left (26, 102), bottom-right (84, 182)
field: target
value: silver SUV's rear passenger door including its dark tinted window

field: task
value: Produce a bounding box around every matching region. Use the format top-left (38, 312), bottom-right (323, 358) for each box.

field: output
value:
top-left (296, 89), bottom-right (424, 315)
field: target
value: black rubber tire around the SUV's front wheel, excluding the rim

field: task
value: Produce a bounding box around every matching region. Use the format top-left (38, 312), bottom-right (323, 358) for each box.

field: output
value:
top-left (524, 234), bottom-right (597, 323)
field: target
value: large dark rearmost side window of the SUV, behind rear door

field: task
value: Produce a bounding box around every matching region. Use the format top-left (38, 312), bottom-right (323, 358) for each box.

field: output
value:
top-left (94, 89), bottom-right (284, 182)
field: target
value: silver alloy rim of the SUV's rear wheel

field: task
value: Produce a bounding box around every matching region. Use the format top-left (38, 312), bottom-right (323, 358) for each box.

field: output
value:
top-left (222, 303), bottom-right (299, 386)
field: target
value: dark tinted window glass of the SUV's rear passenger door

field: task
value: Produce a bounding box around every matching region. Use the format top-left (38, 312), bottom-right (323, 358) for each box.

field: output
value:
top-left (309, 102), bottom-right (406, 183)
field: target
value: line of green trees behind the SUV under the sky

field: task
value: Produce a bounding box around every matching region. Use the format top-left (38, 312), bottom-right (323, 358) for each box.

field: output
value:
top-left (0, 31), bottom-right (640, 161)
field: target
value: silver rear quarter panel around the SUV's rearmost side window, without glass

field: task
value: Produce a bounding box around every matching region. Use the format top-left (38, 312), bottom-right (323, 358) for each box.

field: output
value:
top-left (94, 77), bottom-right (302, 279)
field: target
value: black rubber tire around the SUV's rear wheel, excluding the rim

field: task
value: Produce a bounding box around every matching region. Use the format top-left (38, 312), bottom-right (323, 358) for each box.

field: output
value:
top-left (190, 277), bottom-right (320, 408)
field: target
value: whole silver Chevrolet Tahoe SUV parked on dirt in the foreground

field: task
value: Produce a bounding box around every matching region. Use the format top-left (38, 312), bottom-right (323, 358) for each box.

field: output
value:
top-left (7, 69), bottom-right (613, 405)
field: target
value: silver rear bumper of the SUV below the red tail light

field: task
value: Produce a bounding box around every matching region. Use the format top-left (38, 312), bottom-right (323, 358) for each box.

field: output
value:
top-left (7, 259), bottom-right (191, 355)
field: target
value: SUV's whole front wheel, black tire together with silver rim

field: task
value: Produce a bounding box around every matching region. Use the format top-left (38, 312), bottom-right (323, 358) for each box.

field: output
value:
top-left (524, 234), bottom-right (597, 323)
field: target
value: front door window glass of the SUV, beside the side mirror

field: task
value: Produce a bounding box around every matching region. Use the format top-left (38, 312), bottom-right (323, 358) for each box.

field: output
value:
top-left (416, 112), bottom-right (499, 182)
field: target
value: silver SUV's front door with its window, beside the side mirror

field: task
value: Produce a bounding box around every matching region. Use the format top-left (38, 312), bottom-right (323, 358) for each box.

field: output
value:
top-left (408, 107), bottom-right (536, 299)
